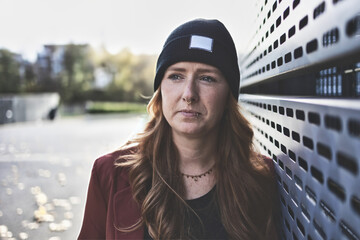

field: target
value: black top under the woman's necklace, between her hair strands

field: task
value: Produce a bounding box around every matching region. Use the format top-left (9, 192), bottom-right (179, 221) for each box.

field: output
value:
top-left (144, 187), bottom-right (227, 240)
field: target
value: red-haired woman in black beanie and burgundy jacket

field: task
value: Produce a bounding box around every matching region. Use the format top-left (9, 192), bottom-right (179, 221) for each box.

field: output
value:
top-left (79, 19), bottom-right (276, 239)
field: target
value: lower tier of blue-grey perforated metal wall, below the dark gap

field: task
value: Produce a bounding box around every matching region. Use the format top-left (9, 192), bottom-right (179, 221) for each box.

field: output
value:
top-left (243, 95), bottom-right (360, 239)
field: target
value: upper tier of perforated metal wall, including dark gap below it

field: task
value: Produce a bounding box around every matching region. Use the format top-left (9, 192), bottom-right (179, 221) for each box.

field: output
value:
top-left (241, 0), bottom-right (360, 97)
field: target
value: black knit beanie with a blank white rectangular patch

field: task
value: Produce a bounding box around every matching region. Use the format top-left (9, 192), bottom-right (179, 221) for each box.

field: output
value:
top-left (154, 19), bottom-right (240, 99)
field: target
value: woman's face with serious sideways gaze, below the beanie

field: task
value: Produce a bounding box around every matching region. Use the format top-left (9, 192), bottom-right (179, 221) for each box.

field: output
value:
top-left (160, 62), bottom-right (230, 137)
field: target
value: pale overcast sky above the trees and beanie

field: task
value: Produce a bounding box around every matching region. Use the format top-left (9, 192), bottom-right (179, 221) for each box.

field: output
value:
top-left (0, 0), bottom-right (255, 61)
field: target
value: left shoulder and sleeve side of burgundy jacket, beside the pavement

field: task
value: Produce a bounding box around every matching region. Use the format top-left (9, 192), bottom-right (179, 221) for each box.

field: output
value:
top-left (78, 150), bottom-right (144, 239)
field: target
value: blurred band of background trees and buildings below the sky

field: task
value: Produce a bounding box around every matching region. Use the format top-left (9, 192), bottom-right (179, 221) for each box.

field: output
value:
top-left (0, 44), bottom-right (156, 103)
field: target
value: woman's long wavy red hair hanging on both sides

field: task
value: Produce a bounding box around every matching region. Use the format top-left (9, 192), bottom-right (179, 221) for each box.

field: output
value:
top-left (116, 90), bottom-right (276, 239)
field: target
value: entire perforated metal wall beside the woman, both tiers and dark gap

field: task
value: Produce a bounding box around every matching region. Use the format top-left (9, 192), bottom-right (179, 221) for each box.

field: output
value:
top-left (239, 0), bottom-right (360, 240)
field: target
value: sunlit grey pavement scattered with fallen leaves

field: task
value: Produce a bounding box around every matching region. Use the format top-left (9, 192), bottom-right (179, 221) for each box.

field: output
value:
top-left (0, 114), bottom-right (146, 240)
